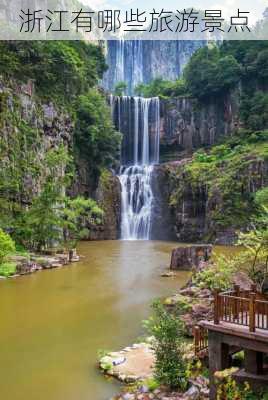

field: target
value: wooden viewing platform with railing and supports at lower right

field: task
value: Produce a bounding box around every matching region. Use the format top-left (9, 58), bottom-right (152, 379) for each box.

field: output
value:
top-left (194, 285), bottom-right (268, 399)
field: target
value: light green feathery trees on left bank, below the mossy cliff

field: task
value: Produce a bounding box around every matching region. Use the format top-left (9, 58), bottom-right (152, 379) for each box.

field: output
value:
top-left (3, 141), bottom-right (103, 251)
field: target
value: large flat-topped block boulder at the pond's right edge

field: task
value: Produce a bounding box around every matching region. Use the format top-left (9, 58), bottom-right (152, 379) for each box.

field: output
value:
top-left (170, 244), bottom-right (212, 270)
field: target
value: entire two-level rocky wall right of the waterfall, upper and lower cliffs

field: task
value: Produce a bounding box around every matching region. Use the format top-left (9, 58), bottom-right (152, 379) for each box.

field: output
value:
top-left (152, 92), bottom-right (268, 244)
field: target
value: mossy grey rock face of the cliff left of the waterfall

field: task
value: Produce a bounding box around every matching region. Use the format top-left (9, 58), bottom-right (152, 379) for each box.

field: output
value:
top-left (0, 79), bottom-right (120, 239)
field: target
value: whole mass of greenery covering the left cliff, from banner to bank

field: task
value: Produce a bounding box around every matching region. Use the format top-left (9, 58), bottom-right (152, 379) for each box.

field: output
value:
top-left (0, 41), bottom-right (121, 250)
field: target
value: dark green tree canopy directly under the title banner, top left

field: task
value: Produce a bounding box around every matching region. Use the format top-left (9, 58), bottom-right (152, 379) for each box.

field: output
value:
top-left (0, 41), bottom-right (106, 104)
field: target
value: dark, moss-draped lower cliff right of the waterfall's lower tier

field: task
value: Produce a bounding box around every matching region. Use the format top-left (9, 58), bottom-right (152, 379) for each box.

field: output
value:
top-left (155, 156), bottom-right (268, 245)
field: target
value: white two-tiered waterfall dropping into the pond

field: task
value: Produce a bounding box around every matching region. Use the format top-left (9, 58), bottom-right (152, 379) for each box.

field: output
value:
top-left (111, 96), bottom-right (160, 240)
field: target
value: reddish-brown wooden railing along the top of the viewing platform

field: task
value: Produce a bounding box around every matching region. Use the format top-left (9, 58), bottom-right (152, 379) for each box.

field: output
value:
top-left (214, 285), bottom-right (268, 332)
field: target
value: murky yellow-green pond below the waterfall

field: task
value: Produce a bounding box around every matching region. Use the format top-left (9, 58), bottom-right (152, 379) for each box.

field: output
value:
top-left (0, 241), bottom-right (232, 400)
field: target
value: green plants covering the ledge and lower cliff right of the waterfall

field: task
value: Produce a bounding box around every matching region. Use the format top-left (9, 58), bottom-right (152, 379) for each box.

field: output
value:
top-left (170, 131), bottom-right (268, 234)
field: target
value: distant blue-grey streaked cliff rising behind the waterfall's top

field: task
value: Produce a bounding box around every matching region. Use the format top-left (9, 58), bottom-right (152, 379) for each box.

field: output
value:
top-left (102, 40), bottom-right (204, 95)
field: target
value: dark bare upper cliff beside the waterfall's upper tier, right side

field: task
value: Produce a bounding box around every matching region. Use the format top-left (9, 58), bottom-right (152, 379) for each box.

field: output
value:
top-left (160, 93), bottom-right (239, 161)
